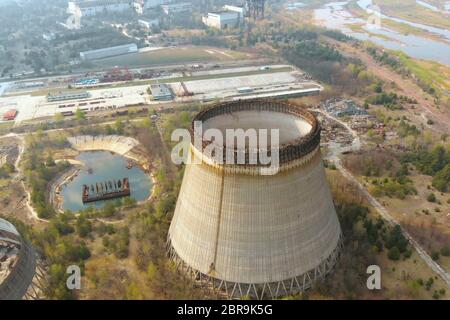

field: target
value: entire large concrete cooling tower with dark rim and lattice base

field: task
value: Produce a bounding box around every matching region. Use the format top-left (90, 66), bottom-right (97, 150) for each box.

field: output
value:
top-left (167, 100), bottom-right (342, 299)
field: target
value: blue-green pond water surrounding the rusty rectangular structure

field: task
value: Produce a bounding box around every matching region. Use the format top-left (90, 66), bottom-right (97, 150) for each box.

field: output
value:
top-left (61, 151), bottom-right (152, 212)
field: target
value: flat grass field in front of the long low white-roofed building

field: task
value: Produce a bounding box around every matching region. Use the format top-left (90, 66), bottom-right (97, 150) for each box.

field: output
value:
top-left (92, 47), bottom-right (248, 68)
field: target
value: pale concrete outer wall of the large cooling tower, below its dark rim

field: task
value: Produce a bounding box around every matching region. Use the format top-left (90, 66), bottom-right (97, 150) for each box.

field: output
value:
top-left (169, 149), bottom-right (341, 284)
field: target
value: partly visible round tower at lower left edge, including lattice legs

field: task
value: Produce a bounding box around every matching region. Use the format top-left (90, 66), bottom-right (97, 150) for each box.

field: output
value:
top-left (0, 219), bottom-right (43, 300)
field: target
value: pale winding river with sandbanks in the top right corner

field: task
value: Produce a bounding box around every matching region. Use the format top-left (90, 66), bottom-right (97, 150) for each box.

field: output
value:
top-left (314, 0), bottom-right (450, 66)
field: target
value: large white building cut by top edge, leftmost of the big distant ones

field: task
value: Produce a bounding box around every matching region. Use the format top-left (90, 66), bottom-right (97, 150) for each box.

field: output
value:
top-left (68, 0), bottom-right (131, 17)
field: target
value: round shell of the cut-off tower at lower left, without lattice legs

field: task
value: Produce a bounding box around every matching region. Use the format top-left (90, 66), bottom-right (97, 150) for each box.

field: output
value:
top-left (0, 218), bottom-right (37, 301)
